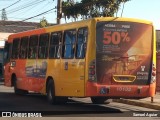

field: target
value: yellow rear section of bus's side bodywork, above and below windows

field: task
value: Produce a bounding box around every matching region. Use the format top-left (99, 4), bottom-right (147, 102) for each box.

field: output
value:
top-left (42, 20), bottom-right (91, 97)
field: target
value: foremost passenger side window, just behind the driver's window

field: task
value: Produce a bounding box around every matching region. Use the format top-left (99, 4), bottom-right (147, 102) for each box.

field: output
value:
top-left (11, 38), bottom-right (20, 59)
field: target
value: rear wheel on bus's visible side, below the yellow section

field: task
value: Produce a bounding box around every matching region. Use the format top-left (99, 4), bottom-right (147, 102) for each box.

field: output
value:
top-left (47, 79), bottom-right (56, 104)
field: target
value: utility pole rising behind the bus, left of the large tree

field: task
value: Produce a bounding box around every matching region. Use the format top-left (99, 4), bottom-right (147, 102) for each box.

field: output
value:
top-left (57, 0), bottom-right (62, 24)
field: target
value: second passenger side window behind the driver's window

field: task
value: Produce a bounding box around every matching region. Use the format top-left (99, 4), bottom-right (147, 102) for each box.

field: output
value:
top-left (19, 36), bottom-right (28, 59)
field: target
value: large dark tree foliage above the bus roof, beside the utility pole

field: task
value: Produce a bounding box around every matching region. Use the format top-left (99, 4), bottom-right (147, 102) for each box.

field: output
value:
top-left (62, 0), bottom-right (129, 19)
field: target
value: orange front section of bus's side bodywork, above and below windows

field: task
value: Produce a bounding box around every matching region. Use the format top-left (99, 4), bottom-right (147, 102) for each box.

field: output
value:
top-left (4, 28), bottom-right (45, 91)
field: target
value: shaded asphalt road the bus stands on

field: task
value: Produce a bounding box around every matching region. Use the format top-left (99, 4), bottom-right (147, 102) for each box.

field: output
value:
top-left (0, 83), bottom-right (160, 117)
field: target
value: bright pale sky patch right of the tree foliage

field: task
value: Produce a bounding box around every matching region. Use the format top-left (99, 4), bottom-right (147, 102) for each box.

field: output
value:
top-left (119, 0), bottom-right (160, 30)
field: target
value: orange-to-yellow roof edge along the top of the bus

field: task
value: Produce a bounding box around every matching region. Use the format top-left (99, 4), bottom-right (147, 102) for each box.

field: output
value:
top-left (9, 17), bottom-right (152, 39)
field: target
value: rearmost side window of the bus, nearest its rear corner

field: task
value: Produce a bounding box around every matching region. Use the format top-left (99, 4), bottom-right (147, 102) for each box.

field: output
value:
top-left (76, 28), bottom-right (88, 59)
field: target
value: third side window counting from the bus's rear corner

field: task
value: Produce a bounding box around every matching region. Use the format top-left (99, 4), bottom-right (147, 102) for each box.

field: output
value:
top-left (49, 32), bottom-right (62, 58)
